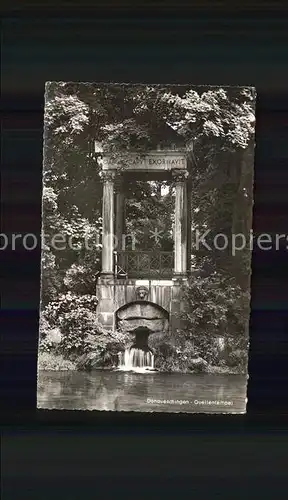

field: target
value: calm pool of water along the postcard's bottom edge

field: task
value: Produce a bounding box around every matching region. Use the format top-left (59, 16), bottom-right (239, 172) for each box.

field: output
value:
top-left (37, 371), bottom-right (247, 413)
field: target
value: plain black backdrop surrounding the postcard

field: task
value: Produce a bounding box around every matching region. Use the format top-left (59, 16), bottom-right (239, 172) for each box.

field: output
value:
top-left (1, 1), bottom-right (288, 500)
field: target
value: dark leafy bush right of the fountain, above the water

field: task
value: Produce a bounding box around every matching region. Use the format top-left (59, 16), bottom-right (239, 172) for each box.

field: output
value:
top-left (182, 271), bottom-right (249, 369)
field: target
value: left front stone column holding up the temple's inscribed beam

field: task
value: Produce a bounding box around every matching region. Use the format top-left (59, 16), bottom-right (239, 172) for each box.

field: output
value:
top-left (101, 171), bottom-right (115, 276)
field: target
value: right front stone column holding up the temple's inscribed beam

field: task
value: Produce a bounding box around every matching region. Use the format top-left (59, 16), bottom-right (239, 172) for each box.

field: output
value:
top-left (173, 170), bottom-right (188, 277)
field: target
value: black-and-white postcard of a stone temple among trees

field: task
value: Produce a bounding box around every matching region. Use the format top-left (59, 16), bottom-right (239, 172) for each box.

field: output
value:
top-left (37, 82), bottom-right (256, 413)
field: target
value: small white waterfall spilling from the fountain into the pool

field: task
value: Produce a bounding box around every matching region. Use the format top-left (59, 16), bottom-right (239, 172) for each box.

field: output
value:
top-left (118, 347), bottom-right (154, 372)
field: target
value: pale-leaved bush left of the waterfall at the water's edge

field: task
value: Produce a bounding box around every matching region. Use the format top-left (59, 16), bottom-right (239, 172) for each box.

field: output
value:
top-left (39, 292), bottom-right (131, 369)
